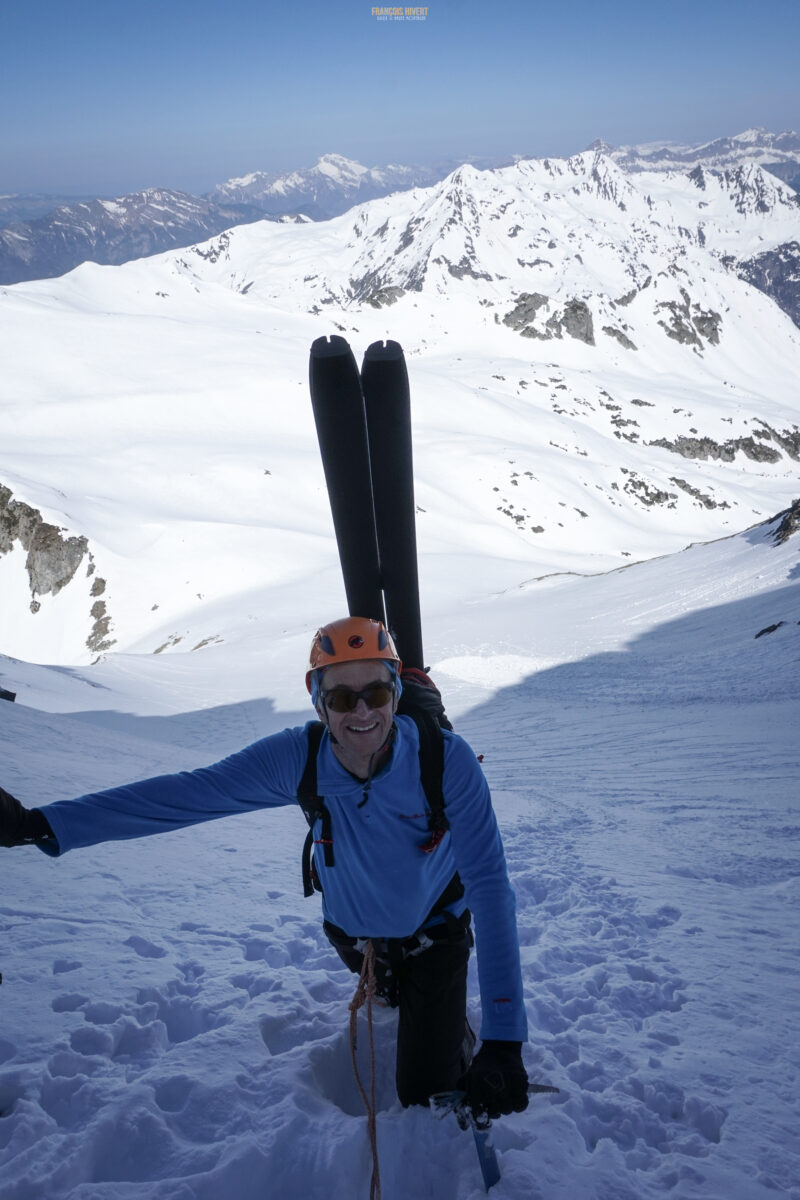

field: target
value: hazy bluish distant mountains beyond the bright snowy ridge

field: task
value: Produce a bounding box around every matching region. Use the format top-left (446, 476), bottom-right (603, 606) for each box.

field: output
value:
top-left (0, 130), bottom-right (800, 325)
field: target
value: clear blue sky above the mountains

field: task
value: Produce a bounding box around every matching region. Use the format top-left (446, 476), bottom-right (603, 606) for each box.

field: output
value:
top-left (0, 0), bottom-right (800, 194)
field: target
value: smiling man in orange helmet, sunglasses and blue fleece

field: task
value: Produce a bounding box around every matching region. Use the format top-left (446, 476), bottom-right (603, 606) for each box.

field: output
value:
top-left (0, 617), bottom-right (528, 1116)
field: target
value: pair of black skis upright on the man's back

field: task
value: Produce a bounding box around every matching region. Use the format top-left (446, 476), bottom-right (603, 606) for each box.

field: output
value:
top-left (309, 336), bottom-right (423, 667)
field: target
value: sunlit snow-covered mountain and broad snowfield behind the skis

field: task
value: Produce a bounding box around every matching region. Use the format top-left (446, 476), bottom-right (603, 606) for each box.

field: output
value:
top-left (0, 152), bottom-right (800, 662)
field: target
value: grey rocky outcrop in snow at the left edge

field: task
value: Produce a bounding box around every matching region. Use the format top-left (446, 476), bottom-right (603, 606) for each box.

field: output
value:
top-left (0, 484), bottom-right (114, 652)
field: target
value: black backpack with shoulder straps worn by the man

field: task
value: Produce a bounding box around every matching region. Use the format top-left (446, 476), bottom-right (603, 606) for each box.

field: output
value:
top-left (297, 667), bottom-right (463, 902)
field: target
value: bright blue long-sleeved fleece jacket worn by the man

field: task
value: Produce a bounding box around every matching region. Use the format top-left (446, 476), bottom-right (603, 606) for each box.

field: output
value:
top-left (42, 716), bottom-right (528, 1042)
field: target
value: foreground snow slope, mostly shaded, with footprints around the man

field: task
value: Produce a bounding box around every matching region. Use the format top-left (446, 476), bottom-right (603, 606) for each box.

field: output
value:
top-left (0, 511), bottom-right (800, 1200)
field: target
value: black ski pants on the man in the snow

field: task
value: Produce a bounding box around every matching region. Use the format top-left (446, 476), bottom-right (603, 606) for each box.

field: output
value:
top-left (325, 922), bottom-right (475, 1108)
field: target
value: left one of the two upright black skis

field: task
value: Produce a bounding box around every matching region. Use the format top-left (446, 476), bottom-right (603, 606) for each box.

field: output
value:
top-left (308, 335), bottom-right (386, 620)
